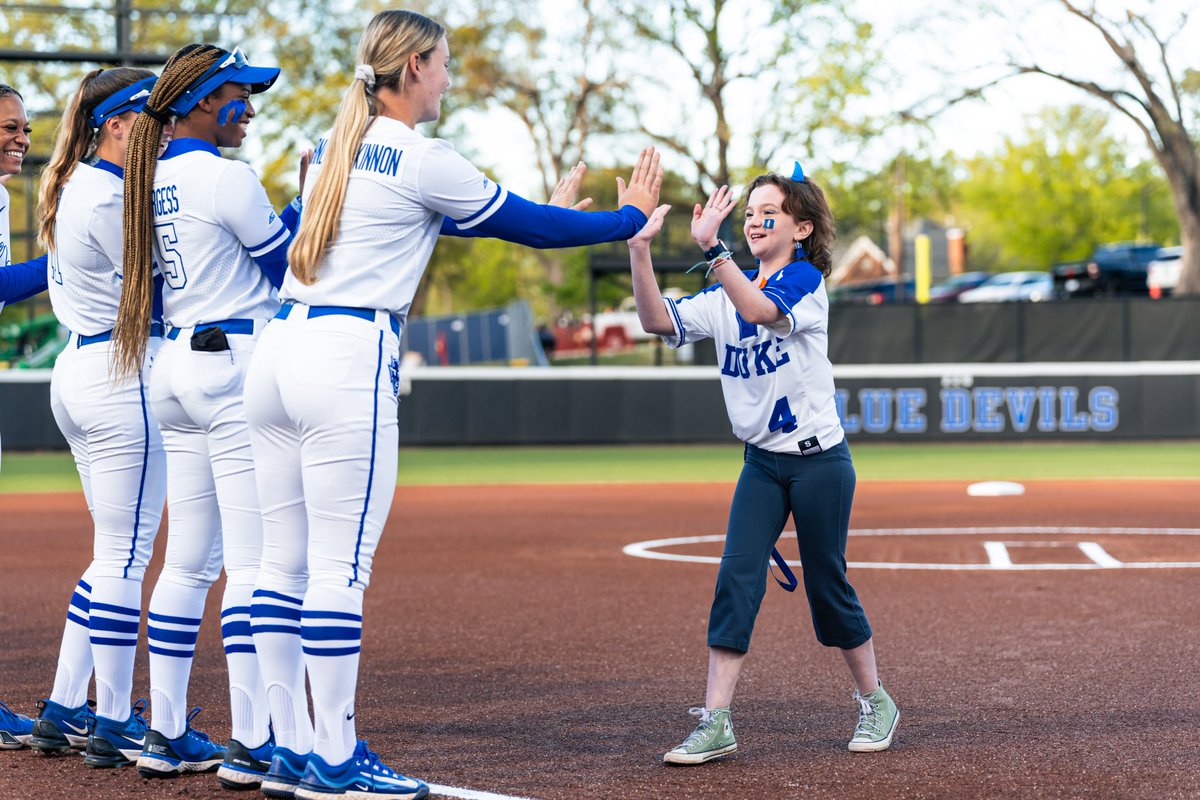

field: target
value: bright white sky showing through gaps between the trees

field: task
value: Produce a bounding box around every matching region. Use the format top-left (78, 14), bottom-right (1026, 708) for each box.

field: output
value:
top-left (451, 0), bottom-right (1200, 197)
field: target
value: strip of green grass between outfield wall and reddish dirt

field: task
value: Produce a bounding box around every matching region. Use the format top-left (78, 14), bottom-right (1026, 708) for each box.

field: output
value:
top-left (0, 441), bottom-right (1200, 493)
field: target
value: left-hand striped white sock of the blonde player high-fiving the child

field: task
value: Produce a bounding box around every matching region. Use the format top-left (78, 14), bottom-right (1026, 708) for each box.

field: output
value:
top-left (250, 584), bottom-right (312, 753)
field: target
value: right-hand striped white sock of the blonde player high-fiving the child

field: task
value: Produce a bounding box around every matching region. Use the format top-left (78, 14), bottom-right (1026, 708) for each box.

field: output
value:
top-left (300, 585), bottom-right (362, 764)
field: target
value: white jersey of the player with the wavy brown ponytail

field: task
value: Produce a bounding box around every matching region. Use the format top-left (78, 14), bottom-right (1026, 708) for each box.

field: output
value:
top-left (47, 161), bottom-right (125, 336)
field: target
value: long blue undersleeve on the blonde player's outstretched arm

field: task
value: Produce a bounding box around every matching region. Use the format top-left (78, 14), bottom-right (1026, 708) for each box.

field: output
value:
top-left (442, 192), bottom-right (646, 249)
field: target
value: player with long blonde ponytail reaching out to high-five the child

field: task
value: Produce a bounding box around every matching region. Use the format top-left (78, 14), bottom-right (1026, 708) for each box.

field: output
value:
top-left (246, 11), bottom-right (661, 798)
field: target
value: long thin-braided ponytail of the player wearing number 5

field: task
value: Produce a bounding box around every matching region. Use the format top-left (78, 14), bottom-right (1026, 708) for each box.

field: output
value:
top-left (113, 44), bottom-right (228, 378)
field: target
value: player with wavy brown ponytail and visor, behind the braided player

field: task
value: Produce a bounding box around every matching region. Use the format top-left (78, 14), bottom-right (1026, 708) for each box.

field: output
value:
top-left (21, 67), bottom-right (167, 766)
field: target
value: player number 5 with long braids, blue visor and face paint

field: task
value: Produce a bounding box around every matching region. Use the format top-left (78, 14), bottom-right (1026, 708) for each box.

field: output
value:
top-left (111, 40), bottom-right (295, 787)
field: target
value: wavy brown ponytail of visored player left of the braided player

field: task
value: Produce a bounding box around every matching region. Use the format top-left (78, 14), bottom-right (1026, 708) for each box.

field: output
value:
top-left (37, 67), bottom-right (154, 251)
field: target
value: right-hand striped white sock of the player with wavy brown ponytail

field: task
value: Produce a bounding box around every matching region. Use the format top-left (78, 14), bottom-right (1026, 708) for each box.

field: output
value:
top-left (89, 578), bottom-right (142, 722)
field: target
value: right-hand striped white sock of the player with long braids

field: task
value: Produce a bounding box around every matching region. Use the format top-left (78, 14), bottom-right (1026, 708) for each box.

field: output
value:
top-left (221, 576), bottom-right (271, 747)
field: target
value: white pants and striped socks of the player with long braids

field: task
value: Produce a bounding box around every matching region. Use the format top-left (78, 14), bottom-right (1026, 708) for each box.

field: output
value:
top-left (148, 320), bottom-right (269, 747)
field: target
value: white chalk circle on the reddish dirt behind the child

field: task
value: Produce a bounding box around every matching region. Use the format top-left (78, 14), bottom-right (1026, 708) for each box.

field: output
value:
top-left (622, 525), bottom-right (1200, 572)
